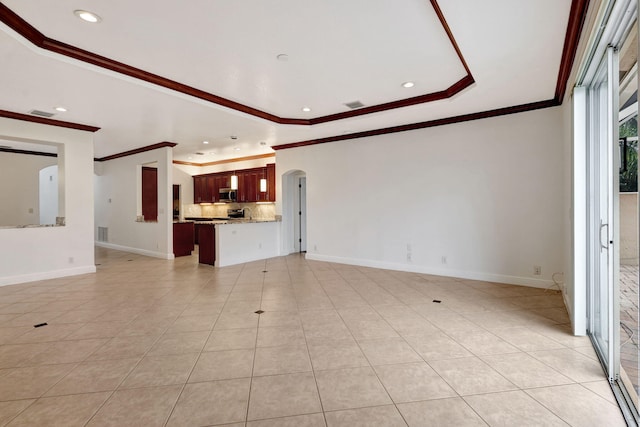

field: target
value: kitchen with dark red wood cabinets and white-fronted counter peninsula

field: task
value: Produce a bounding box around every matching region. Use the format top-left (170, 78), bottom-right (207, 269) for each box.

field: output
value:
top-left (173, 163), bottom-right (280, 267)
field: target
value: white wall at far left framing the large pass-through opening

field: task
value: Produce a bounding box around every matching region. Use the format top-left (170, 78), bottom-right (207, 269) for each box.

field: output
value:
top-left (0, 118), bottom-right (95, 285)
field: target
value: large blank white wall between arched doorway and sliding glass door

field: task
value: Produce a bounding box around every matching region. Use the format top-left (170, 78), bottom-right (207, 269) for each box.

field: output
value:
top-left (276, 108), bottom-right (565, 287)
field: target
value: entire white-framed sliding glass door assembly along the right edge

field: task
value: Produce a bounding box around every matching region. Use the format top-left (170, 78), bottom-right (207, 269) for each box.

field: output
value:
top-left (574, 0), bottom-right (640, 424)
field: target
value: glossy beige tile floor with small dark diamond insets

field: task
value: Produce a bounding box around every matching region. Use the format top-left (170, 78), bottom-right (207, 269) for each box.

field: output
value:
top-left (0, 249), bottom-right (625, 427)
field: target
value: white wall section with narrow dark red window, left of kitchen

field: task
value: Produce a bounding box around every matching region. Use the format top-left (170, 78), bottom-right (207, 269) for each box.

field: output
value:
top-left (94, 147), bottom-right (173, 259)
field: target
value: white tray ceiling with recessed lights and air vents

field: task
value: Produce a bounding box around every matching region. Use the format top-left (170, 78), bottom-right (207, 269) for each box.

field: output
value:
top-left (0, 0), bottom-right (571, 163)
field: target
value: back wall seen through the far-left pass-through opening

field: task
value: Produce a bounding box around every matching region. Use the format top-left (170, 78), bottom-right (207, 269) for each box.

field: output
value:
top-left (0, 153), bottom-right (58, 226)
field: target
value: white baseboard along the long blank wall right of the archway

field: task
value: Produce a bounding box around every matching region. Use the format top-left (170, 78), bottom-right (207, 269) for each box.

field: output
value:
top-left (306, 252), bottom-right (553, 289)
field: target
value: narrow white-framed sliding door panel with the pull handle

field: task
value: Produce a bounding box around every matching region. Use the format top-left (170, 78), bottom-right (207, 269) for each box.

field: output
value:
top-left (587, 47), bottom-right (619, 380)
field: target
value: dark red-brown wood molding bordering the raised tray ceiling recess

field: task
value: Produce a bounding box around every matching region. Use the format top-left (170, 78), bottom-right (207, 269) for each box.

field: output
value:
top-left (0, 0), bottom-right (472, 125)
